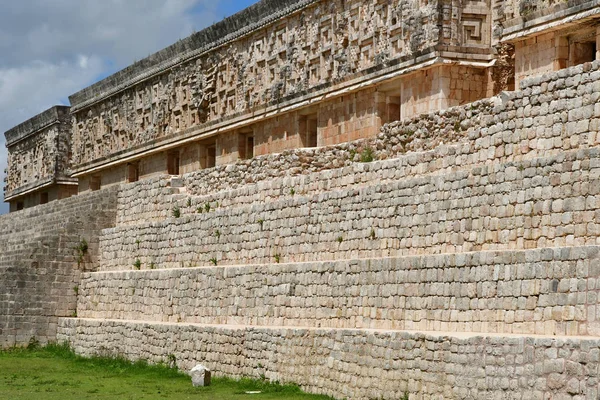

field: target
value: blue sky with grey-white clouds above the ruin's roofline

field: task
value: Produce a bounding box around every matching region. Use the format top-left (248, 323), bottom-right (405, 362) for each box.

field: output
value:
top-left (0, 0), bottom-right (257, 213)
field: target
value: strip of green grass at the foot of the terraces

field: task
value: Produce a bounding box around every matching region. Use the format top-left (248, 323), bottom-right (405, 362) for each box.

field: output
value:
top-left (0, 345), bottom-right (336, 400)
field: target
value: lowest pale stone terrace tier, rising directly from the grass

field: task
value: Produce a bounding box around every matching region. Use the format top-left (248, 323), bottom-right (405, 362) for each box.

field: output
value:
top-left (57, 318), bottom-right (600, 400)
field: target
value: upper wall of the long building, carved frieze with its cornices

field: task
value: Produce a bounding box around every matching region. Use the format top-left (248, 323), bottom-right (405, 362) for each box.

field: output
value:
top-left (70, 0), bottom-right (493, 174)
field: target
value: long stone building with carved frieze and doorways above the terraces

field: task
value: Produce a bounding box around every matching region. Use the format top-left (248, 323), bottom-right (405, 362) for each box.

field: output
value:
top-left (70, 0), bottom-right (499, 191)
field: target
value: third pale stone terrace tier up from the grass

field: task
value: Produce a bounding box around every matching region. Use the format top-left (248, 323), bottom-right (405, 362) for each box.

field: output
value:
top-left (101, 149), bottom-right (600, 270)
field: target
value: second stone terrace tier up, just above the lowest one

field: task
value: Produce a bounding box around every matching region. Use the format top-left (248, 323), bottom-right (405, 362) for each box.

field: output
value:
top-left (78, 246), bottom-right (600, 335)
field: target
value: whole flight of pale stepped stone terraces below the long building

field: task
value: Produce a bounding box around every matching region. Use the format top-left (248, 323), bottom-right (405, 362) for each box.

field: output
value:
top-left (58, 61), bottom-right (600, 400)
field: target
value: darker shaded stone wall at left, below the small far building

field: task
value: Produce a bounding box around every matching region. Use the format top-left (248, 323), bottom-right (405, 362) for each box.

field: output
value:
top-left (0, 188), bottom-right (118, 347)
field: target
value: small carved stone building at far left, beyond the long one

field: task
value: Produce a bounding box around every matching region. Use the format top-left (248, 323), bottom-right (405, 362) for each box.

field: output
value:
top-left (4, 106), bottom-right (77, 211)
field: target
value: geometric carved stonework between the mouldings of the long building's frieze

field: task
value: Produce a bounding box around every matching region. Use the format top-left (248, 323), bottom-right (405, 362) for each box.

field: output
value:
top-left (71, 0), bottom-right (490, 169)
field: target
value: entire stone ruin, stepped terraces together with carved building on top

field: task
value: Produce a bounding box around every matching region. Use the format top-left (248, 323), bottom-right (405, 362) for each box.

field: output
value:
top-left (0, 0), bottom-right (600, 400)
